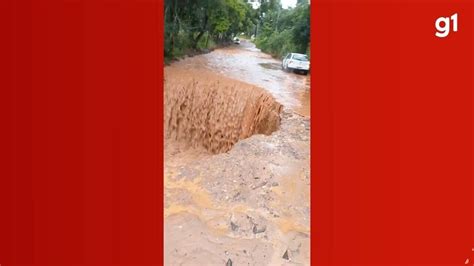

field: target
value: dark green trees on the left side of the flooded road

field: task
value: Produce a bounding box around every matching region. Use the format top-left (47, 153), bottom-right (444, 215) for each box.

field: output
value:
top-left (164, 0), bottom-right (254, 58)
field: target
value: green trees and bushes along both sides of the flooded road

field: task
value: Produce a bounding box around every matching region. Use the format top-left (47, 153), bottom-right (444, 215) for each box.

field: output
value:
top-left (164, 0), bottom-right (310, 61)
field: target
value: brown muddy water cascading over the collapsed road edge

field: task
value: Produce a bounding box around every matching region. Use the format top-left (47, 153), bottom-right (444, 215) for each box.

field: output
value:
top-left (164, 69), bottom-right (282, 153)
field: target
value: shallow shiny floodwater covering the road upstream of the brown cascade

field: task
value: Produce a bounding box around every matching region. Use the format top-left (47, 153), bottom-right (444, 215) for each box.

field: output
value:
top-left (173, 40), bottom-right (310, 117)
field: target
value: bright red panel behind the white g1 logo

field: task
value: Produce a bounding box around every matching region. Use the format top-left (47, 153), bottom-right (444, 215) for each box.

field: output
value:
top-left (311, 0), bottom-right (474, 265)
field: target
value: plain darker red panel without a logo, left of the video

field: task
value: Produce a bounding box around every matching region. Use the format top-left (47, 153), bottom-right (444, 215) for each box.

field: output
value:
top-left (0, 0), bottom-right (163, 265)
